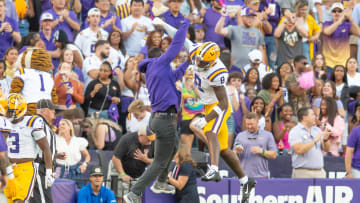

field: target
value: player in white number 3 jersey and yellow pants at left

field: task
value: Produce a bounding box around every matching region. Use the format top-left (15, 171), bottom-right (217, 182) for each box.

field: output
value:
top-left (4, 94), bottom-right (55, 203)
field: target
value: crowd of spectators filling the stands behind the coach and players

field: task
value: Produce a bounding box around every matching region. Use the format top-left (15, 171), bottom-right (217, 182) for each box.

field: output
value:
top-left (0, 0), bottom-right (360, 201)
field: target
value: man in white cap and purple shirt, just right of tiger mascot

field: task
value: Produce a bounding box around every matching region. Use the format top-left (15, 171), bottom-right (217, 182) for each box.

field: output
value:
top-left (39, 13), bottom-right (61, 71)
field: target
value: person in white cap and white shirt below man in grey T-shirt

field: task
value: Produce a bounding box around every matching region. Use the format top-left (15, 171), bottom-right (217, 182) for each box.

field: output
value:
top-left (244, 49), bottom-right (273, 82)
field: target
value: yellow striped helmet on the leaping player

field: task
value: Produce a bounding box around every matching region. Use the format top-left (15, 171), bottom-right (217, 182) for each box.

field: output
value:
top-left (195, 42), bottom-right (220, 71)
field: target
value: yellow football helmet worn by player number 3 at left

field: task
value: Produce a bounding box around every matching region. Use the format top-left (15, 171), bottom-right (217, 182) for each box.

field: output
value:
top-left (6, 93), bottom-right (27, 121)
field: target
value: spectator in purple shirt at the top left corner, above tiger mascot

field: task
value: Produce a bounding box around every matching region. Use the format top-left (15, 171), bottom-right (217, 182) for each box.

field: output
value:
top-left (0, 0), bottom-right (21, 59)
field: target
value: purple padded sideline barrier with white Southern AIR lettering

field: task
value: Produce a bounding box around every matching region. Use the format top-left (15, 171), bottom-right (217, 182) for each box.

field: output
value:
top-left (52, 178), bottom-right (360, 203)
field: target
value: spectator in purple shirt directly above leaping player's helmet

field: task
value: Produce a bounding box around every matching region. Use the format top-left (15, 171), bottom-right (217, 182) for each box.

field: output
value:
top-left (200, 0), bottom-right (230, 48)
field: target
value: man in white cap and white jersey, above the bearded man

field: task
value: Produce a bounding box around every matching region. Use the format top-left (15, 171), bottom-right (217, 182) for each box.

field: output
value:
top-left (75, 8), bottom-right (109, 57)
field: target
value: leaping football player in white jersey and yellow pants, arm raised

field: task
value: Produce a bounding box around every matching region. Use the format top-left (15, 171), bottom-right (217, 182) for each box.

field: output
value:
top-left (153, 18), bottom-right (256, 203)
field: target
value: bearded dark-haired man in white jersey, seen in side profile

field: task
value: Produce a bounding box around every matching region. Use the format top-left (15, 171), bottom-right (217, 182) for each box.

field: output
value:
top-left (82, 40), bottom-right (110, 90)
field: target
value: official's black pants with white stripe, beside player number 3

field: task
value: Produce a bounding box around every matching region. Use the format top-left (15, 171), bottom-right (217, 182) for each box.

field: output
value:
top-left (30, 162), bottom-right (53, 203)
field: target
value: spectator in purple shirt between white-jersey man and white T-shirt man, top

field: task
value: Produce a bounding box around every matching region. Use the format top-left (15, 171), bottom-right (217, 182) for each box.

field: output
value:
top-left (85, 0), bottom-right (121, 33)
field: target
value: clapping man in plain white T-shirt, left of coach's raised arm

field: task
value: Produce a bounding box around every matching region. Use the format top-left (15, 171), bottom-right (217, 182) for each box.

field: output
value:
top-left (121, 0), bottom-right (154, 56)
